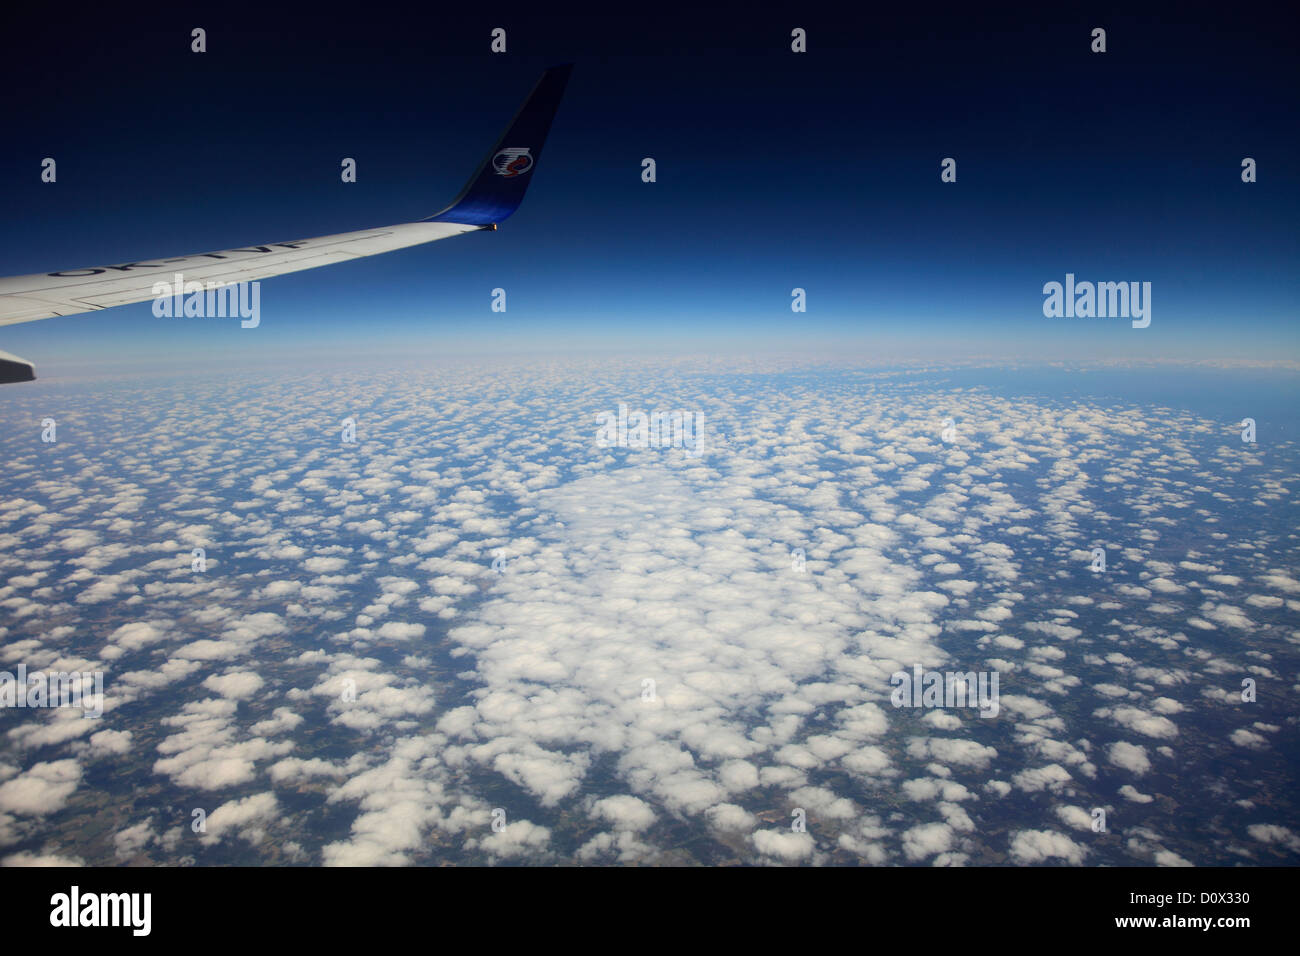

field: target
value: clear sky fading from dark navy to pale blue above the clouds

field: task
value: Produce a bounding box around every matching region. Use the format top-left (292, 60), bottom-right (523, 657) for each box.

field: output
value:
top-left (0, 4), bottom-right (1300, 373)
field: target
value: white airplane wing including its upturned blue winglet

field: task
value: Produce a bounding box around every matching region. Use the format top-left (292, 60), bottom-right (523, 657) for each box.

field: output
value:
top-left (0, 65), bottom-right (573, 384)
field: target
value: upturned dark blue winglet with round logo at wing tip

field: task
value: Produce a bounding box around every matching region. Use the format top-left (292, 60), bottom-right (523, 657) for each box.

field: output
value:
top-left (424, 64), bottom-right (573, 226)
